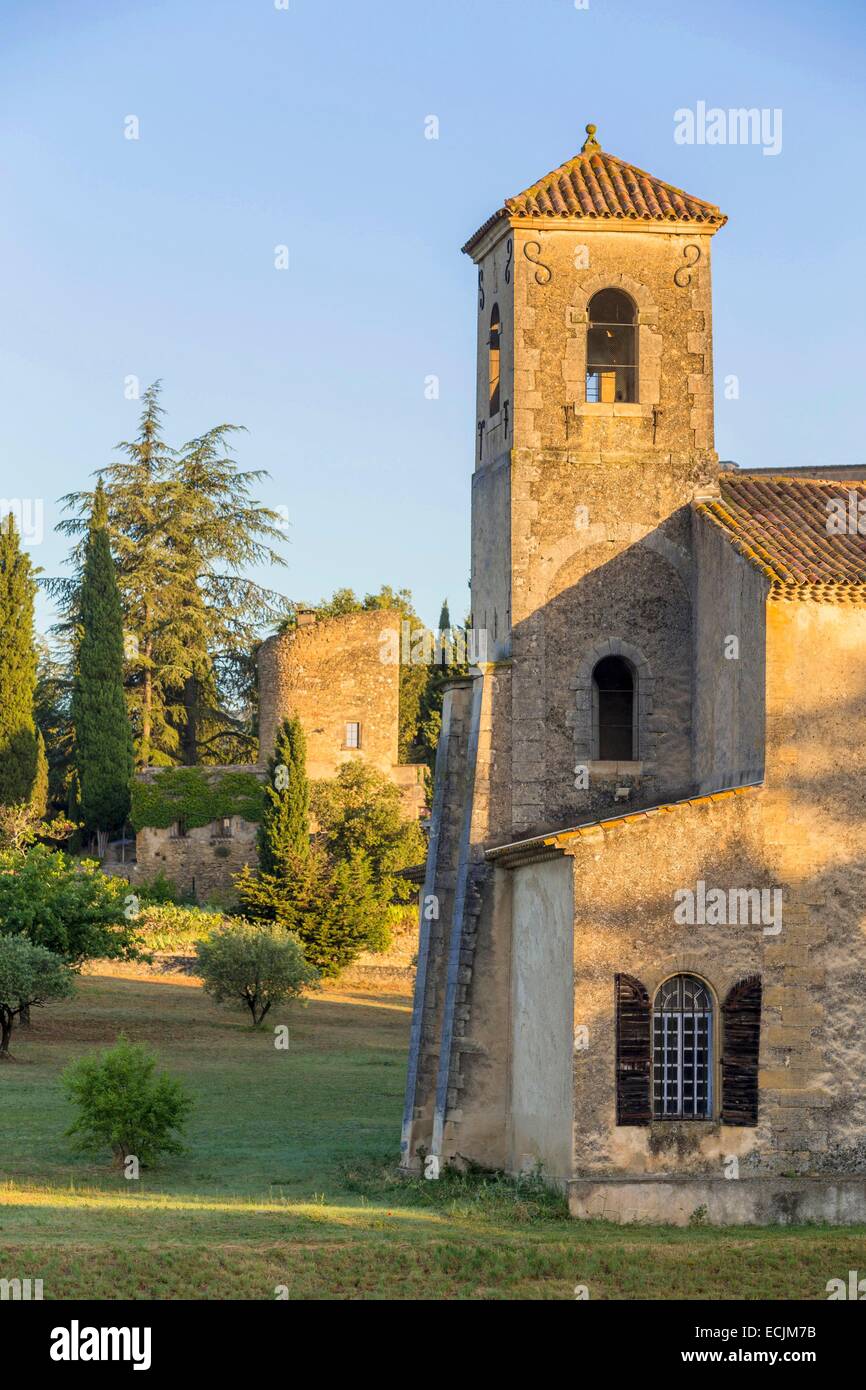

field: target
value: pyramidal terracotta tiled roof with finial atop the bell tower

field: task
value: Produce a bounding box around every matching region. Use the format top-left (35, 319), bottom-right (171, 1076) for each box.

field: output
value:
top-left (463, 126), bottom-right (727, 252)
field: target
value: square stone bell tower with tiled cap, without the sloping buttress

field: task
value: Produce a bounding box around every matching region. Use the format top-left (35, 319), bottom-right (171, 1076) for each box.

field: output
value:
top-left (464, 125), bottom-right (726, 838)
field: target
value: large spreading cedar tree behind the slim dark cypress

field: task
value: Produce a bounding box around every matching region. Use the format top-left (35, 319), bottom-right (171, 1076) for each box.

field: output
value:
top-left (49, 382), bottom-right (285, 767)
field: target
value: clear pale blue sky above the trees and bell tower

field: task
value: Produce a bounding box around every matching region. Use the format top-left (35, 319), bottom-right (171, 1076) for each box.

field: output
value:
top-left (0, 0), bottom-right (866, 636)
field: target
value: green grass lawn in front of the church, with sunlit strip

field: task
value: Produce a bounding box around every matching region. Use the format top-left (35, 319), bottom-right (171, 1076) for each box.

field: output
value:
top-left (0, 966), bottom-right (866, 1300)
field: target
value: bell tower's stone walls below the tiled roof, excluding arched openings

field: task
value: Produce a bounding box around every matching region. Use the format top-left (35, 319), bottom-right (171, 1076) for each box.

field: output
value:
top-left (473, 222), bottom-right (717, 837)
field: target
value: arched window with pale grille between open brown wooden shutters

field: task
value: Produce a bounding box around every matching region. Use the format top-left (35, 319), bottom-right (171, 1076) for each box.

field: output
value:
top-left (652, 974), bottom-right (713, 1120)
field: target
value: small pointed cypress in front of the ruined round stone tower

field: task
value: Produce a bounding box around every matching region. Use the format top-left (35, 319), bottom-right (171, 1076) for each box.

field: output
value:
top-left (259, 719), bottom-right (310, 880)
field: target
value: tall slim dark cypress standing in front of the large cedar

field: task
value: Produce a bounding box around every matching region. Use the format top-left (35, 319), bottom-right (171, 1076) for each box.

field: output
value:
top-left (72, 481), bottom-right (132, 853)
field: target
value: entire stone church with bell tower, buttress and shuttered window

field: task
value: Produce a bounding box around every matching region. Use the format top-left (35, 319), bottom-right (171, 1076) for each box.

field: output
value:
top-left (403, 126), bottom-right (866, 1222)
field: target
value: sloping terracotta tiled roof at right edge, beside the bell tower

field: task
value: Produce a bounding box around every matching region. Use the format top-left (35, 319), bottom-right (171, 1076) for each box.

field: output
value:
top-left (698, 470), bottom-right (866, 602)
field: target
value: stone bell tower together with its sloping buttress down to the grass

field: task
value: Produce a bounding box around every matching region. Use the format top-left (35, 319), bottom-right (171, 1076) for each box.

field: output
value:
top-left (402, 126), bottom-right (726, 1176)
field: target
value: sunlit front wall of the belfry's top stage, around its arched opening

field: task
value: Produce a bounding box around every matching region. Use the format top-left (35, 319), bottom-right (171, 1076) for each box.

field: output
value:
top-left (514, 224), bottom-right (713, 464)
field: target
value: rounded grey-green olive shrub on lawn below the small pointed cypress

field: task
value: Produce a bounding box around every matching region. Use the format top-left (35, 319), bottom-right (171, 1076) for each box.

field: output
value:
top-left (196, 919), bottom-right (318, 1026)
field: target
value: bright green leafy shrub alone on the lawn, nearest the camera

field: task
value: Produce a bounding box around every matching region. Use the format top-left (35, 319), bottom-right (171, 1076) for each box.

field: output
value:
top-left (61, 1033), bottom-right (192, 1168)
